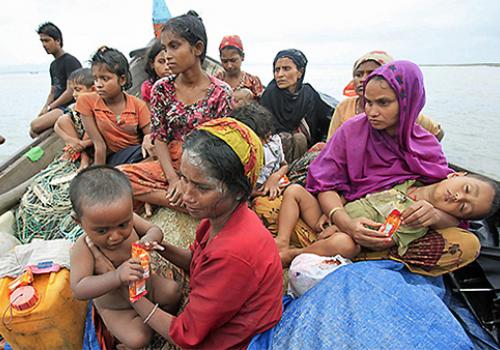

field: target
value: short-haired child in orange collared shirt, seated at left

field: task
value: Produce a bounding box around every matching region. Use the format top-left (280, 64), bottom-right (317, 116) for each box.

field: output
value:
top-left (76, 46), bottom-right (152, 166)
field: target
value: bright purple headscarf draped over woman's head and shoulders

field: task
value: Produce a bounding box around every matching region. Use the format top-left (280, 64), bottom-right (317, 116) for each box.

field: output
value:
top-left (306, 61), bottom-right (451, 201)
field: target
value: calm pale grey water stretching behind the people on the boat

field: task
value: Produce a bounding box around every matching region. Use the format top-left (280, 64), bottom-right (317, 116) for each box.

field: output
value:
top-left (0, 65), bottom-right (500, 180)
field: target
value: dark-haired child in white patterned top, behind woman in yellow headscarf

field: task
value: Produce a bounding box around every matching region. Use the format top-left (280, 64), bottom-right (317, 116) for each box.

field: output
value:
top-left (233, 102), bottom-right (288, 199)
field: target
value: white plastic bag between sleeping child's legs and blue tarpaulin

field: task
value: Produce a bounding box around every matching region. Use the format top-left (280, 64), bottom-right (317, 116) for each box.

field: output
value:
top-left (288, 253), bottom-right (352, 298)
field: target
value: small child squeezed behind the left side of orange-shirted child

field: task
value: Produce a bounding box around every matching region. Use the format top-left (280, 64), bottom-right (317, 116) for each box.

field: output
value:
top-left (54, 68), bottom-right (95, 170)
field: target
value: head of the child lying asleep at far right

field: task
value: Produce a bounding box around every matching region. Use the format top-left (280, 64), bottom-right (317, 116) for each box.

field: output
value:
top-left (432, 173), bottom-right (500, 220)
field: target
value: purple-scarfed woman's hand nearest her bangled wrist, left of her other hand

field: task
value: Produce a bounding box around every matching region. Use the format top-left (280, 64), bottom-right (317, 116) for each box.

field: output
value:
top-left (345, 217), bottom-right (394, 250)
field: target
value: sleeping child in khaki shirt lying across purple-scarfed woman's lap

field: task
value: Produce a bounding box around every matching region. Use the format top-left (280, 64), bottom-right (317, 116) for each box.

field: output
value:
top-left (276, 173), bottom-right (500, 266)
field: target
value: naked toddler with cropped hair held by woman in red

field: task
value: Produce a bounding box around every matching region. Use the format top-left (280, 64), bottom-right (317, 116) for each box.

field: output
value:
top-left (70, 166), bottom-right (180, 348)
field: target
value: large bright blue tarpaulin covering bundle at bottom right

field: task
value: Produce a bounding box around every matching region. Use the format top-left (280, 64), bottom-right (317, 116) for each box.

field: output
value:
top-left (249, 260), bottom-right (474, 350)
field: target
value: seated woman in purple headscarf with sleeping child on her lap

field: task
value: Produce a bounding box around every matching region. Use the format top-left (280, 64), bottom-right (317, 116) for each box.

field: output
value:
top-left (306, 61), bottom-right (478, 274)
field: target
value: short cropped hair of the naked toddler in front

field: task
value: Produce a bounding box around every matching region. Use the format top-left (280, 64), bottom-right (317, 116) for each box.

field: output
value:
top-left (69, 165), bottom-right (133, 218)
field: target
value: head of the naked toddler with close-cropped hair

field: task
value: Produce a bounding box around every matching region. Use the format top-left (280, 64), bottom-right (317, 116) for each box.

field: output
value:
top-left (69, 165), bottom-right (134, 250)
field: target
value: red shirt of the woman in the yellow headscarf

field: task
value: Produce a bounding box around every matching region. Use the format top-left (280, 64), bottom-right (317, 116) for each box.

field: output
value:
top-left (169, 203), bottom-right (283, 349)
